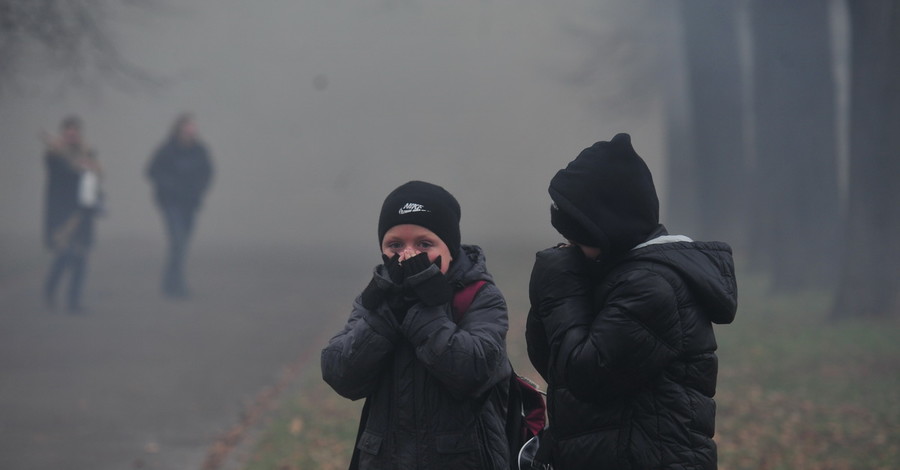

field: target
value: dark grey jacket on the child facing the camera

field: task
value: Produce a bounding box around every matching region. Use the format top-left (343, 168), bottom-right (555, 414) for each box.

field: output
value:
top-left (322, 245), bottom-right (511, 470)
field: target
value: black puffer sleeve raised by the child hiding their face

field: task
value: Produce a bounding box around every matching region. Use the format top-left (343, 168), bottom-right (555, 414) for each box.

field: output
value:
top-left (555, 270), bottom-right (682, 401)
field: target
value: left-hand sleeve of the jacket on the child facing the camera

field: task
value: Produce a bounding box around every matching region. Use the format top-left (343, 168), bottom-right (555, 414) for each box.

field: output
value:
top-left (322, 298), bottom-right (400, 400)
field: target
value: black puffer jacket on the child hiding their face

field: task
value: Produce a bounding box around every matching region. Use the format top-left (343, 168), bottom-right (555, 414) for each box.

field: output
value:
top-left (526, 236), bottom-right (737, 470)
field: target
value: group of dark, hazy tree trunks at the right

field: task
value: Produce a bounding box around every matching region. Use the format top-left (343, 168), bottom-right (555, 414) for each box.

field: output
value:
top-left (669, 0), bottom-right (900, 318)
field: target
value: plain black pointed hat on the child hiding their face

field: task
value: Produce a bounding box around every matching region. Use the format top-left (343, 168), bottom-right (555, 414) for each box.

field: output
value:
top-left (549, 134), bottom-right (659, 255)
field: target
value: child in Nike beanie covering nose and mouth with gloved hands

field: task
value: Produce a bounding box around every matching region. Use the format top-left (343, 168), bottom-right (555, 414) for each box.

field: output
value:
top-left (322, 181), bottom-right (511, 470)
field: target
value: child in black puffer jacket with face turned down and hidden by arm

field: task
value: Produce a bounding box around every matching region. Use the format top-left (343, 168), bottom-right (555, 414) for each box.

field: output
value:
top-left (526, 134), bottom-right (737, 470)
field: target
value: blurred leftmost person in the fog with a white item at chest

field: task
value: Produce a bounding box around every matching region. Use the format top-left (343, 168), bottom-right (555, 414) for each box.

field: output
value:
top-left (42, 115), bottom-right (102, 313)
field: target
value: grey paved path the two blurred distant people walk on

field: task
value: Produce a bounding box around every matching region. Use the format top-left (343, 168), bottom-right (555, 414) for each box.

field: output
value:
top-left (0, 241), bottom-right (365, 470)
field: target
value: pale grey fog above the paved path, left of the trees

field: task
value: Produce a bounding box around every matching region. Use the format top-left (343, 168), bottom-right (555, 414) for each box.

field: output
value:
top-left (0, 0), bottom-right (675, 253)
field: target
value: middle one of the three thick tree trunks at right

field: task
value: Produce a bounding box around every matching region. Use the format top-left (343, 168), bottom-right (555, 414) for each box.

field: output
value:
top-left (750, 0), bottom-right (840, 291)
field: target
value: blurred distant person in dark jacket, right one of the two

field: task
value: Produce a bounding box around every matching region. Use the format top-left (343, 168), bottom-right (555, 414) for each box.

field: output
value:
top-left (147, 113), bottom-right (213, 298)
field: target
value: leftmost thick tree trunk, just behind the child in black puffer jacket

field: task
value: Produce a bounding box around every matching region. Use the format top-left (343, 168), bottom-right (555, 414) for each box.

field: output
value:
top-left (668, 0), bottom-right (746, 245)
